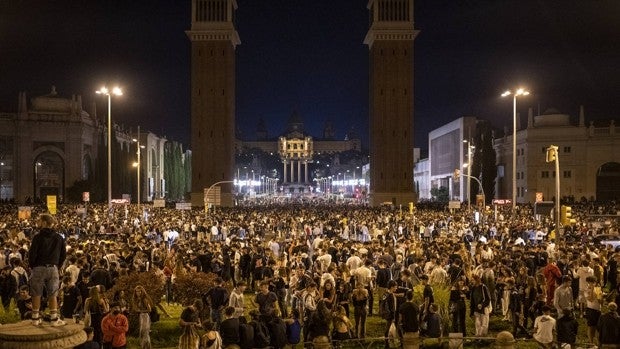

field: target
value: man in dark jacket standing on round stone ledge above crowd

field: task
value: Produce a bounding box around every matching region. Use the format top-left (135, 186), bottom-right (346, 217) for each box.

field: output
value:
top-left (28, 214), bottom-right (67, 326)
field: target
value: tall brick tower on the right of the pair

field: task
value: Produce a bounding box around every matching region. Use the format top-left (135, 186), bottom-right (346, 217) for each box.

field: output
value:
top-left (364, 0), bottom-right (418, 206)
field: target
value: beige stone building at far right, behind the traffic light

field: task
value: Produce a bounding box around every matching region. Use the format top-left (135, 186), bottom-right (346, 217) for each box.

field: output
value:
top-left (494, 107), bottom-right (620, 203)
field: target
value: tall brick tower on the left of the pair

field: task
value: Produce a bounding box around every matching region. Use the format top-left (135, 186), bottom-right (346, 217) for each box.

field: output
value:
top-left (186, 0), bottom-right (240, 206)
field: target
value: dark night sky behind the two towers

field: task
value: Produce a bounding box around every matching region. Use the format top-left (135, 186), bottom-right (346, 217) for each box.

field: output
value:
top-left (0, 0), bottom-right (620, 152)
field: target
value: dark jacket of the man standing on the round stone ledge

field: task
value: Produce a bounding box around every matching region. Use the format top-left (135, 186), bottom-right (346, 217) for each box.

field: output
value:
top-left (28, 228), bottom-right (67, 268)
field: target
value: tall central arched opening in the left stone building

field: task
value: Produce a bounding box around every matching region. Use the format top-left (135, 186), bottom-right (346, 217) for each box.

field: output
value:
top-left (32, 149), bottom-right (65, 201)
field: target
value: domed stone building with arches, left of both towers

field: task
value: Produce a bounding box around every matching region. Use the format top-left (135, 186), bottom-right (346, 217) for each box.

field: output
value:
top-left (0, 87), bottom-right (166, 203)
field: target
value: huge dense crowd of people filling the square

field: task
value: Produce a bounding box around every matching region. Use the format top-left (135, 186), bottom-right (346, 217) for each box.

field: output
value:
top-left (0, 201), bottom-right (620, 349)
